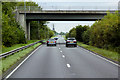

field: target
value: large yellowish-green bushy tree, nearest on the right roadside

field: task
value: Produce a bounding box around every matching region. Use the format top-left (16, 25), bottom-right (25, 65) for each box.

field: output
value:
top-left (89, 11), bottom-right (120, 52)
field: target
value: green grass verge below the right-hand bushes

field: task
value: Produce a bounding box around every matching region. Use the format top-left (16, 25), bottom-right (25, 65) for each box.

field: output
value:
top-left (77, 42), bottom-right (119, 62)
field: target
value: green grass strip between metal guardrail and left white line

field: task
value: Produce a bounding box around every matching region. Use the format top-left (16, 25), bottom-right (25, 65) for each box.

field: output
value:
top-left (0, 43), bottom-right (41, 72)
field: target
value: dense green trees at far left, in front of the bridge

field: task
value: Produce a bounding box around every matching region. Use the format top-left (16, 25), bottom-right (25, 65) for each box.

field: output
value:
top-left (2, 2), bottom-right (25, 46)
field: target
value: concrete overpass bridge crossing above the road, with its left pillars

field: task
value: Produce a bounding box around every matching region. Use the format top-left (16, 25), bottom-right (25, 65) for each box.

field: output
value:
top-left (15, 7), bottom-right (115, 40)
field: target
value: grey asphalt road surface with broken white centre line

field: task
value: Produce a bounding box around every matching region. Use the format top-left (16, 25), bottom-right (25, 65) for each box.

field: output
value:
top-left (7, 36), bottom-right (118, 78)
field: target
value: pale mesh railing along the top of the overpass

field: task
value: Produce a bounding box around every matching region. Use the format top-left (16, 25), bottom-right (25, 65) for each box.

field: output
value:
top-left (16, 6), bottom-right (118, 11)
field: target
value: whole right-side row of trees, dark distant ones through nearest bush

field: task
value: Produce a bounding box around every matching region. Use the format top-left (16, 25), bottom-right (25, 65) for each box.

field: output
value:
top-left (66, 11), bottom-right (120, 53)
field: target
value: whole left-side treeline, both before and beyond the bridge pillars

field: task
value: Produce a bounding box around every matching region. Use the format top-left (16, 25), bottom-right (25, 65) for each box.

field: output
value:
top-left (2, 2), bottom-right (53, 47)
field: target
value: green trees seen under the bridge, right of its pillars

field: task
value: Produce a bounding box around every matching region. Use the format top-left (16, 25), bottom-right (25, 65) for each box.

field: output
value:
top-left (30, 21), bottom-right (54, 40)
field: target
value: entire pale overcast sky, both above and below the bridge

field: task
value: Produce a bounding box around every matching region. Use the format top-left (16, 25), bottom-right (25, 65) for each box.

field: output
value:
top-left (26, 0), bottom-right (120, 33)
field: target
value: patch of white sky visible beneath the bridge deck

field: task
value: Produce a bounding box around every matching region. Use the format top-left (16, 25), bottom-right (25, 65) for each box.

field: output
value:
top-left (48, 21), bottom-right (94, 33)
